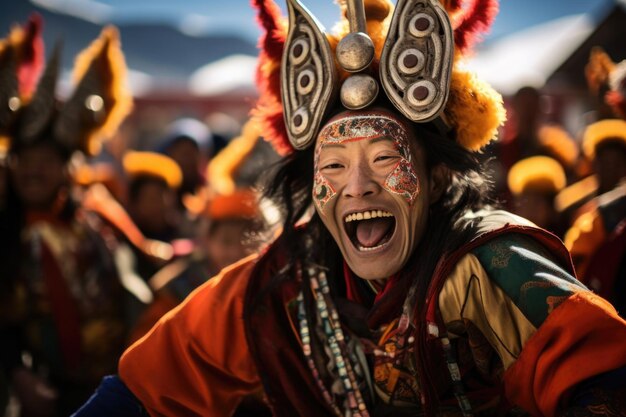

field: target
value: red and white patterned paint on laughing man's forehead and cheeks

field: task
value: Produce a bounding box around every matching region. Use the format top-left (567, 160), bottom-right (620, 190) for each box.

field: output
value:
top-left (313, 115), bottom-right (419, 211)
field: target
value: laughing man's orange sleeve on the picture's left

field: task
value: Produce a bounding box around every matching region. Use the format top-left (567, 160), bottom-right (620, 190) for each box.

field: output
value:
top-left (119, 257), bottom-right (261, 416)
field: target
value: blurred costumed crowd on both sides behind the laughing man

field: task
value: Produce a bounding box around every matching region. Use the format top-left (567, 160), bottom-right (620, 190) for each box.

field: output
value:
top-left (0, 11), bottom-right (626, 416)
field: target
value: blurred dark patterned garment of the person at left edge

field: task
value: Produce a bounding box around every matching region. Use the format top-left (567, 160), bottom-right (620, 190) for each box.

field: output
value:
top-left (2, 206), bottom-right (127, 415)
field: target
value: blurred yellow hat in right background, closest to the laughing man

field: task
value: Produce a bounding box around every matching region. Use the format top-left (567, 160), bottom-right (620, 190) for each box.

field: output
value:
top-left (508, 156), bottom-right (566, 195)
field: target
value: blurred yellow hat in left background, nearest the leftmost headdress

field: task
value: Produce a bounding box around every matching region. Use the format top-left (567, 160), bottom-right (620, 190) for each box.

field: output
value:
top-left (122, 151), bottom-right (183, 188)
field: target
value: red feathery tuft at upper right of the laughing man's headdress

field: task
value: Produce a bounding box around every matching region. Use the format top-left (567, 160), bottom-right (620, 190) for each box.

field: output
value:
top-left (454, 0), bottom-right (499, 54)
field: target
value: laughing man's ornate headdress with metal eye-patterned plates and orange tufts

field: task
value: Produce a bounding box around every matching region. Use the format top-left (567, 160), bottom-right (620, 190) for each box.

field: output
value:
top-left (253, 0), bottom-right (505, 154)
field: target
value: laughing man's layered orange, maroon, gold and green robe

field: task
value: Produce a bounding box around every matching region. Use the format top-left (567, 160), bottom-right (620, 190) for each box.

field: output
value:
top-left (100, 211), bottom-right (626, 416)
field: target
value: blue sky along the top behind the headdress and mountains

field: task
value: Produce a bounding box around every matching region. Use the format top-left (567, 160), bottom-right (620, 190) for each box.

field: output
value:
top-left (31, 0), bottom-right (613, 39)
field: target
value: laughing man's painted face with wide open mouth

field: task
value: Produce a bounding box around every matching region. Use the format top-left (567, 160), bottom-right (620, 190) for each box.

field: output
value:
top-left (313, 109), bottom-right (429, 280)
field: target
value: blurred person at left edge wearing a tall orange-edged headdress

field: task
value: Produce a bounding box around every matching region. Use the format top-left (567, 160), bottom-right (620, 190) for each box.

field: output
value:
top-left (0, 15), bottom-right (132, 416)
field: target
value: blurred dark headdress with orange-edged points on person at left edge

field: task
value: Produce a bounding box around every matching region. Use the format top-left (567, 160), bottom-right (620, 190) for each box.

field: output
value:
top-left (0, 15), bottom-right (132, 155)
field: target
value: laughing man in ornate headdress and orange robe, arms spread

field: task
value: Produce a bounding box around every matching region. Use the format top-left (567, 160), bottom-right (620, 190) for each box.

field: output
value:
top-left (72, 0), bottom-right (626, 416)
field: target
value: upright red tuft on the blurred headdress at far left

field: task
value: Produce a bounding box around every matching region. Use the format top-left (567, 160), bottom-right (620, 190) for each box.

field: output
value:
top-left (17, 13), bottom-right (44, 97)
